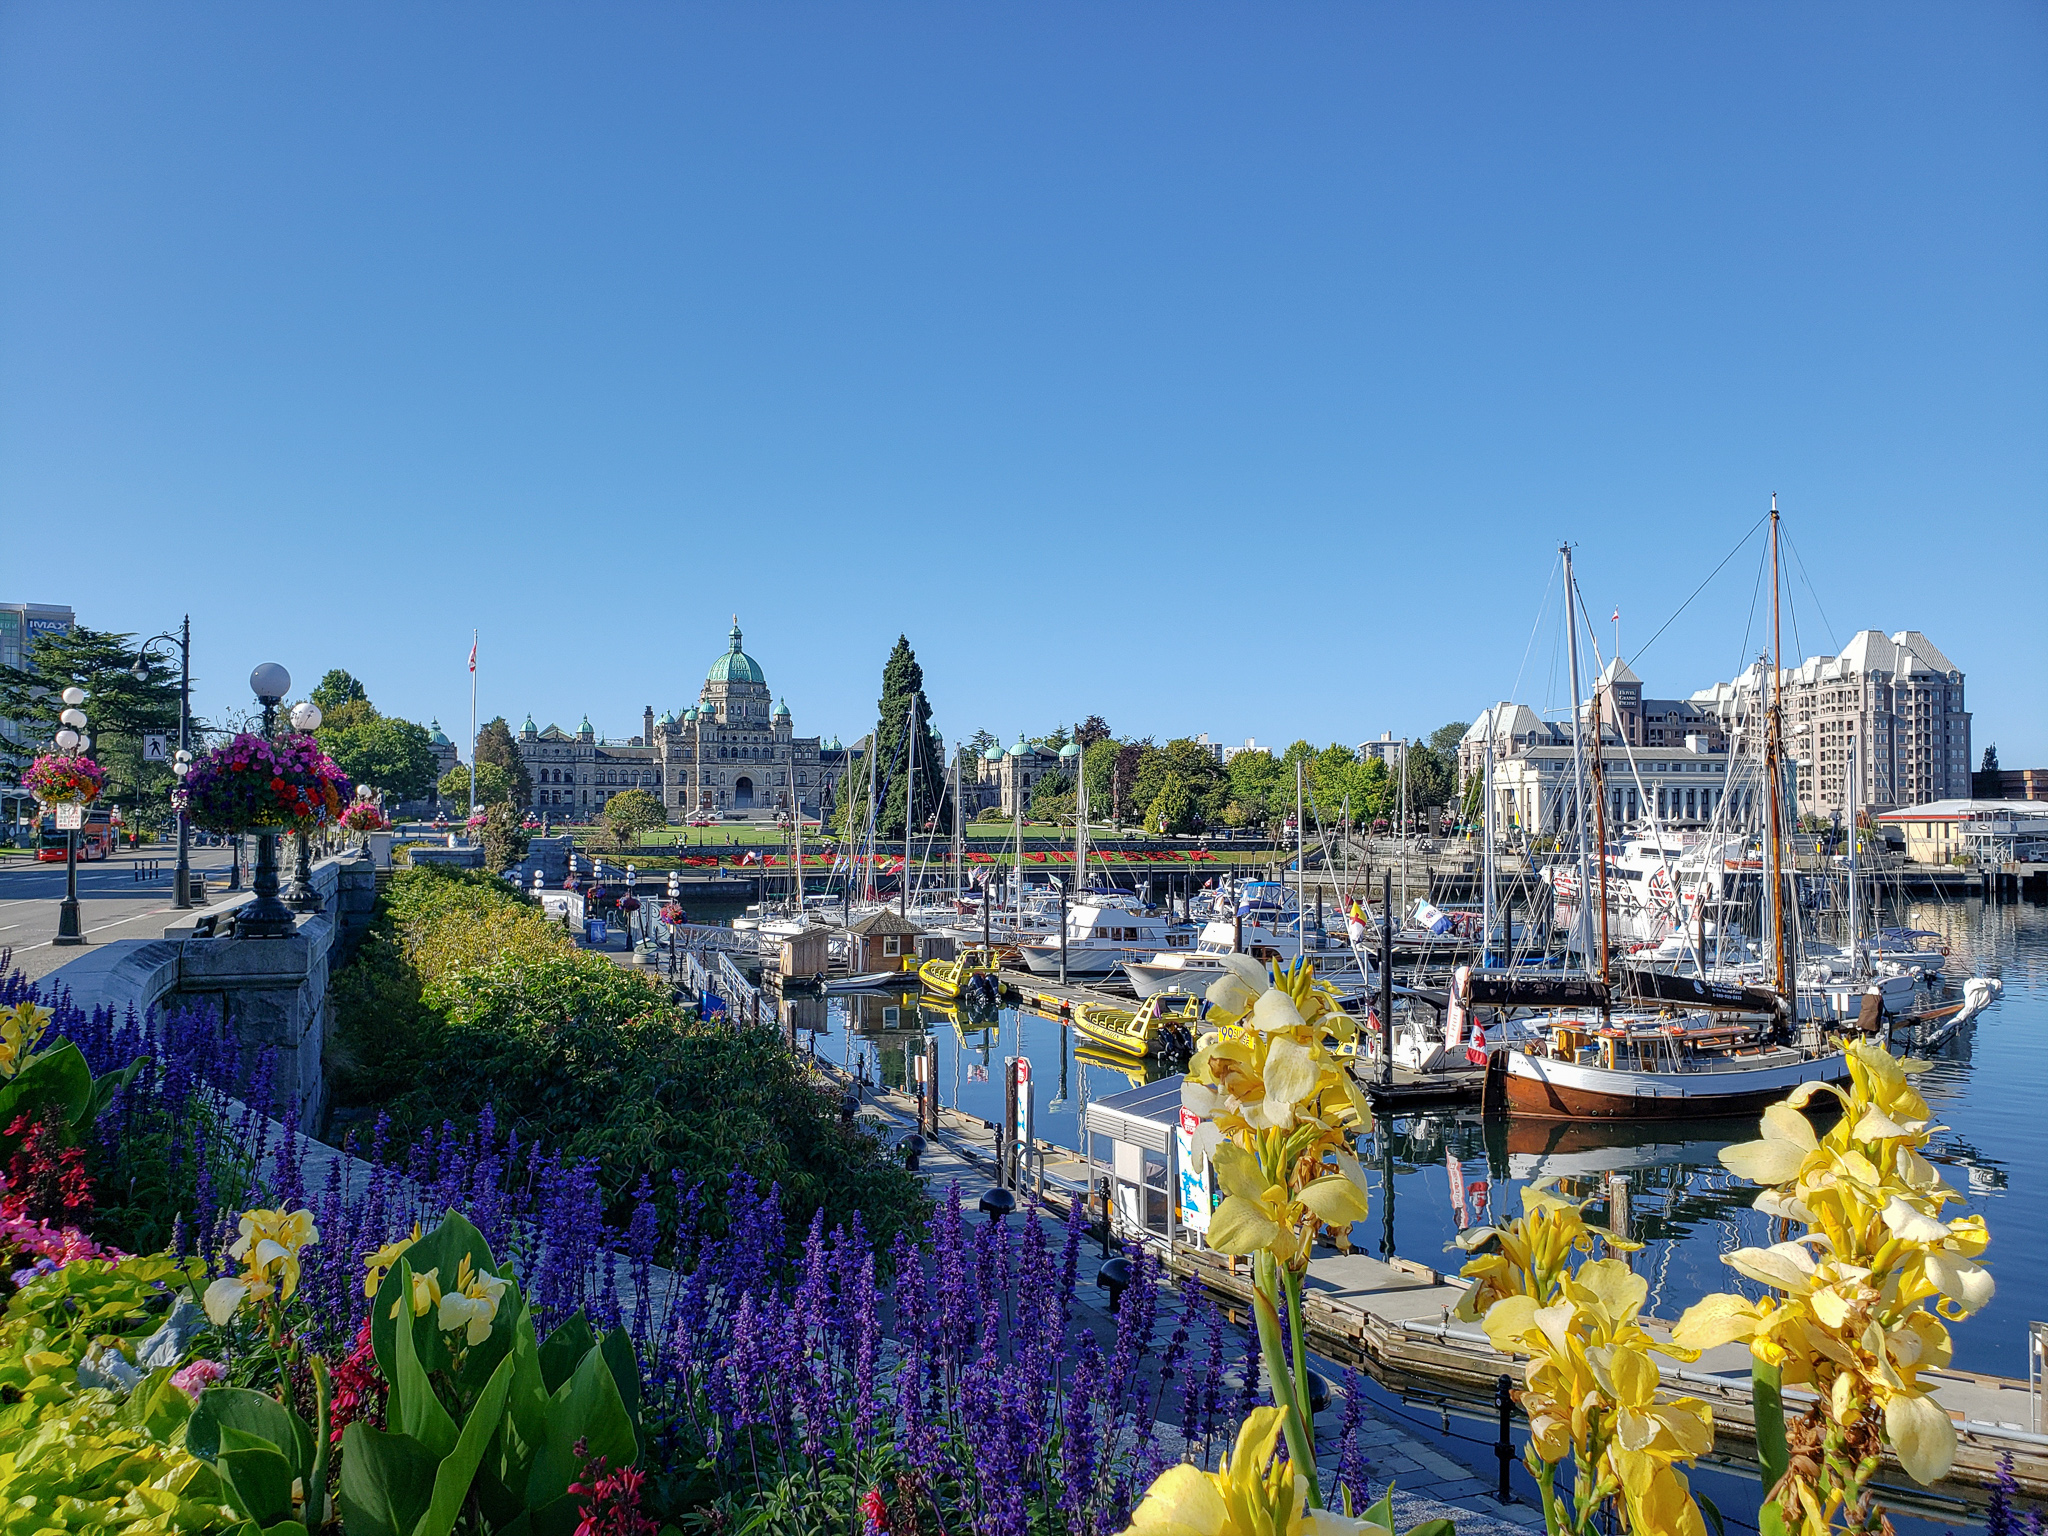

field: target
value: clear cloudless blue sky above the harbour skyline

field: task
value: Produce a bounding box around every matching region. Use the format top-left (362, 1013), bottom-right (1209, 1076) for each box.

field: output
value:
top-left (0, 4), bottom-right (2048, 766)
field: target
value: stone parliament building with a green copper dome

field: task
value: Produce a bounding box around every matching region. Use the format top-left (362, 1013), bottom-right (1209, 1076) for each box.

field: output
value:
top-left (516, 618), bottom-right (846, 821)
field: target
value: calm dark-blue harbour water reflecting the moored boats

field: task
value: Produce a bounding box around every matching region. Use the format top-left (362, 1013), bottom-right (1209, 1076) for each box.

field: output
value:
top-left (778, 899), bottom-right (2048, 1374)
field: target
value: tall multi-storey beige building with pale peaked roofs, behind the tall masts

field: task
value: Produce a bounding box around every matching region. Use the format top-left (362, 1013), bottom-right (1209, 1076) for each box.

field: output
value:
top-left (1688, 629), bottom-right (1970, 817)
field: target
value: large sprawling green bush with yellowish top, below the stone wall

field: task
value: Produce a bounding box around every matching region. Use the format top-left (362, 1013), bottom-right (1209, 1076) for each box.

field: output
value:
top-left (330, 868), bottom-right (924, 1241)
